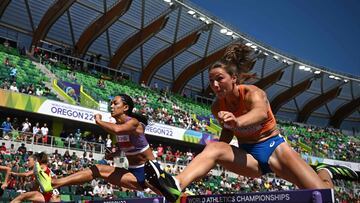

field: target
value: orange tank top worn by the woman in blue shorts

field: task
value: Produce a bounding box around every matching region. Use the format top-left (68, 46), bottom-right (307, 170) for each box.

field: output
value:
top-left (219, 85), bottom-right (276, 138)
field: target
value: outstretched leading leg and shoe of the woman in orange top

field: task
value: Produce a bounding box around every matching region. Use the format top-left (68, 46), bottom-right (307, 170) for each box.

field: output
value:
top-left (145, 142), bottom-right (261, 202)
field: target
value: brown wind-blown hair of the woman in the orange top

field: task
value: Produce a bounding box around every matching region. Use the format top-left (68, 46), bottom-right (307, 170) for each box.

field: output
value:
top-left (209, 44), bottom-right (256, 84)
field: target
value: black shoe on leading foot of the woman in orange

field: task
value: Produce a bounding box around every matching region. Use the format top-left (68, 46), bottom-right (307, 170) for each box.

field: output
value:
top-left (145, 160), bottom-right (181, 202)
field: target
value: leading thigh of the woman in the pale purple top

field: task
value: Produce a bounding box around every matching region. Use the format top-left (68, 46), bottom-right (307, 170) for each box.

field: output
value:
top-left (99, 165), bottom-right (143, 190)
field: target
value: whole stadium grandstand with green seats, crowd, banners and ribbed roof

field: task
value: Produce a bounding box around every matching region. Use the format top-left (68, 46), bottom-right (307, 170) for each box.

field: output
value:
top-left (0, 0), bottom-right (360, 202)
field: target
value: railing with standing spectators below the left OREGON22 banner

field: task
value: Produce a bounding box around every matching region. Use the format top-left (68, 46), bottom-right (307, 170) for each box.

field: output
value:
top-left (0, 128), bottom-right (106, 154)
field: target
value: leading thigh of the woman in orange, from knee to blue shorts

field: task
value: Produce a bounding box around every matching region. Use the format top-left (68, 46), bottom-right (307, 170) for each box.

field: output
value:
top-left (217, 142), bottom-right (261, 177)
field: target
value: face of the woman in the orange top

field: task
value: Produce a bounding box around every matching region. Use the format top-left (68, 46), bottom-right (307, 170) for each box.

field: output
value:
top-left (209, 67), bottom-right (236, 97)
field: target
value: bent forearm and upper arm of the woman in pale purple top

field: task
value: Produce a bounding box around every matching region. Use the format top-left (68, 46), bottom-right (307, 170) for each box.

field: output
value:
top-left (95, 114), bottom-right (139, 135)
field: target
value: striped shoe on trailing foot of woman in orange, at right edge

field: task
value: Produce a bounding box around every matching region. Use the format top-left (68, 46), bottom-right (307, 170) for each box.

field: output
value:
top-left (315, 163), bottom-right (359, 180)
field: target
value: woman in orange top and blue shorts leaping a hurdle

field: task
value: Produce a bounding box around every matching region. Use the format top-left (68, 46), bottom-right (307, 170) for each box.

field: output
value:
top-left (145, 44), bottom-right (357, 202)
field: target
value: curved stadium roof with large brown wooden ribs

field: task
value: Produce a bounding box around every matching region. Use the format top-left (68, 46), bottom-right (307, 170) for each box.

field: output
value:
top-left (0, 0), bottom-right (360, 130)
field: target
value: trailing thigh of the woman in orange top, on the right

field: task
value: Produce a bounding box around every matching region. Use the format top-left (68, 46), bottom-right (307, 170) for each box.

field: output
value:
top-left (269, 142), bottom-right (327, 189)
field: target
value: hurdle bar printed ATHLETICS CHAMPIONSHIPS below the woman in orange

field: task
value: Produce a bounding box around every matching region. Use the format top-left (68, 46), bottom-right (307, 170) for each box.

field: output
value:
top-left (180, 189), bottom-right (335, 203)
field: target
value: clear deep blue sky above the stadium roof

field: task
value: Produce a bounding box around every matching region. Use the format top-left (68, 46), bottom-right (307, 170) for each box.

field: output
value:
top-left (190, 0), bottom-right (360, 77)
